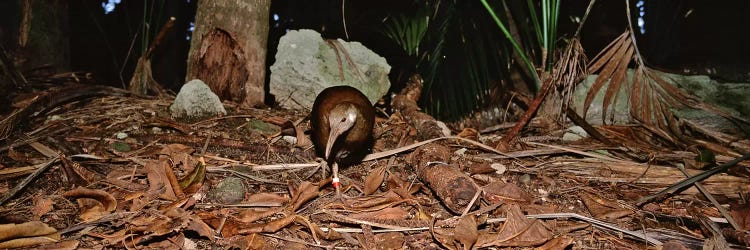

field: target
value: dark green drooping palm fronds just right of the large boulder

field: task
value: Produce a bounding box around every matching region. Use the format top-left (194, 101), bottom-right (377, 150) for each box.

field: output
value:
top-left (383, 0), bottom-right (510, 120)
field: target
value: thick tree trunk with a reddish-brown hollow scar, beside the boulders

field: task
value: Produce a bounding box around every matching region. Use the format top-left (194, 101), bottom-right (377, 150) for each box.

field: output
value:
top-left (186, 0), bottom-right (271, 107)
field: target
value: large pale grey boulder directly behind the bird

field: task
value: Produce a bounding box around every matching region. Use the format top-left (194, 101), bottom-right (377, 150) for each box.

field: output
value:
top-left (270, 30), bottom-right (391, 110)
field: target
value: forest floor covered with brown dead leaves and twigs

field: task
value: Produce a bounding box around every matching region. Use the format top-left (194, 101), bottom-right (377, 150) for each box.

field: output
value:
top-left (0, 82), bottom-right (750, 249)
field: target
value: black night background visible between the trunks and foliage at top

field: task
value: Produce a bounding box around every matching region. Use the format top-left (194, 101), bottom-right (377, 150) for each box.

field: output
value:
top-left (0, 0), bottom-right (750, 109)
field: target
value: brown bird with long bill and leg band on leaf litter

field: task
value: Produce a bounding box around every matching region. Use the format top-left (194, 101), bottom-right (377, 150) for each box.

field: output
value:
top-left (310, 86), bottom-right (375, 199)
